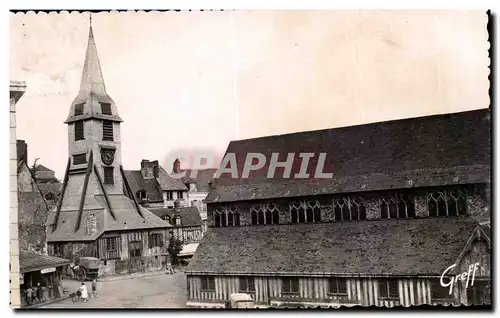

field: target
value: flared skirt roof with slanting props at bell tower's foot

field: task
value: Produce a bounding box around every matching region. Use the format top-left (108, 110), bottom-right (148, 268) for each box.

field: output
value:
top-left (47, 194), bottom-right (171, 242)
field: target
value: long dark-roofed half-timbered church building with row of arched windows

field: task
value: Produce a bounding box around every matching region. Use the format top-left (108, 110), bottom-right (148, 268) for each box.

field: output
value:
top-left (186, 110), bottom-right (490, 307)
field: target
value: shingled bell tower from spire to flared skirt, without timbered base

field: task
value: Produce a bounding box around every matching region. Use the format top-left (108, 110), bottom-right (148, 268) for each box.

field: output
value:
top-left (47, 16), bottom-right (170, 240)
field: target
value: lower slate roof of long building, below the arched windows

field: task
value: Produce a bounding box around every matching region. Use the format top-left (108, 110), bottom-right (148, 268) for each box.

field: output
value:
top-left (185, 219), bottom-right (476, 276)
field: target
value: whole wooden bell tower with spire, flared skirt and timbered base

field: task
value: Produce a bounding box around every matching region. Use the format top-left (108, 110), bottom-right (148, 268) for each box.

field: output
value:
top-left (47, 21), bottom-right (171, 276)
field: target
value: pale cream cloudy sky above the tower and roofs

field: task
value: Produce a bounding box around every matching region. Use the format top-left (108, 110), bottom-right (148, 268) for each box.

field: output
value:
top-left (9, 11), bottom-right (490, 179)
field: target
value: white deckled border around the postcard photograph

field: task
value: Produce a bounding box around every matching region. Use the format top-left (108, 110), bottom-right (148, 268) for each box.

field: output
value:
top-left (0, 0), bottom-right (500, 317)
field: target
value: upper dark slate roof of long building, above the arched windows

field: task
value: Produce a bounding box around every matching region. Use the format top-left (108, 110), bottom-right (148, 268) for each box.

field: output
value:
top-left (206, 109), bottom-right (491, 202)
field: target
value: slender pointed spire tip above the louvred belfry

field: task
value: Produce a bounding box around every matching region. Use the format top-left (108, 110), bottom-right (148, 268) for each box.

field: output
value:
top-left (80, 15), bottom-right (106, 96)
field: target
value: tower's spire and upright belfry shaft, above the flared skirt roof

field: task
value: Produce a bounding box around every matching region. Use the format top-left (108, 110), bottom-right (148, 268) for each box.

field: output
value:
top-left (65, 18), bottom-right (123, 194)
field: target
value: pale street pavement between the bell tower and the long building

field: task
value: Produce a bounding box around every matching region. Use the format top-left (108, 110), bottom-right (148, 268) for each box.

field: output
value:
top-left (40, 272), bottom-right (187, 308)
